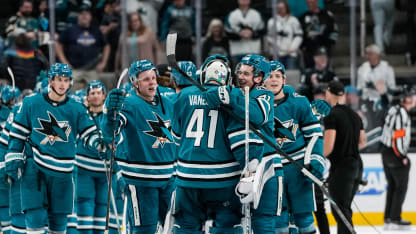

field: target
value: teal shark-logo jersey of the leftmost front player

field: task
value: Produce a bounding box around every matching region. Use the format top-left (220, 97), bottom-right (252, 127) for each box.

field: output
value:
top-left (5, 93), bottom-right (98, 176)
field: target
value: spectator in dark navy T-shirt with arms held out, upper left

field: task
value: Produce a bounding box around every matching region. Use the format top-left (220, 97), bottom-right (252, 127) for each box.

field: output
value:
top-left (56, 7), bottom-right (110, 90)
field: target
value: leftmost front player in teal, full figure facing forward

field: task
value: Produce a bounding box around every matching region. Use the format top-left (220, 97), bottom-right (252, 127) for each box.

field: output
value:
top-left (5, 63), bottom-right (105, 233)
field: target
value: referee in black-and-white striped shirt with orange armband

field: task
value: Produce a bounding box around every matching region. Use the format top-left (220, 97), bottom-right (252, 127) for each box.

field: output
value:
top-left (381, 86), bottom-right (416, 229)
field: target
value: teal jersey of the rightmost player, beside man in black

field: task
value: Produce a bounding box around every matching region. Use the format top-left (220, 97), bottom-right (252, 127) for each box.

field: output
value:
top-left (274, 86), bottom-right (323, 164)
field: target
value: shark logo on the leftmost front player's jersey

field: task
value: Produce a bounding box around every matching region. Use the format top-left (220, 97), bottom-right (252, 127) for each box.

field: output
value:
top-left (35, 111), bottom-right (71, 145)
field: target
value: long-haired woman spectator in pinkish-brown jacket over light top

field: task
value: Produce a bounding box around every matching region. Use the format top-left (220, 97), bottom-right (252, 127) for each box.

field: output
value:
top-left (116, 12), bottom-right (160, 73)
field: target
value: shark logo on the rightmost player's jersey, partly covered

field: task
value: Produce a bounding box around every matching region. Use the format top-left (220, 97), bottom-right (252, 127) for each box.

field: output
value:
top-left (274, 117), bottom-right (299, 147)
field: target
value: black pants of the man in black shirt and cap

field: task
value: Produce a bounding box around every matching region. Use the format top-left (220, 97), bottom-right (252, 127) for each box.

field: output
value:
top-left (328, 157), bottom-right (362, 234)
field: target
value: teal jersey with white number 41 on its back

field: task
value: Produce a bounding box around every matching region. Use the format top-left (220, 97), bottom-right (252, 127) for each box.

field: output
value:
top-left (172, 84), bottom-right (241, 188)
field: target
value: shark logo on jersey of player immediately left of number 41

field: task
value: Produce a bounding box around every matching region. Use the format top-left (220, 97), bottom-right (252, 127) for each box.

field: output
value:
top-left (143, 112), bottom-right (173, 148)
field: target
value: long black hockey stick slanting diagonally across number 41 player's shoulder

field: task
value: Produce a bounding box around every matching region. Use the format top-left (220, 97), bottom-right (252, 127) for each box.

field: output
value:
top-left (166, 33), bottom-right (356, 234)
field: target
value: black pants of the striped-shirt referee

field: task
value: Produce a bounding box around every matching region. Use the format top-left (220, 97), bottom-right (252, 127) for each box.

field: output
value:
top-left (381, 148), bottom-right (410, 221)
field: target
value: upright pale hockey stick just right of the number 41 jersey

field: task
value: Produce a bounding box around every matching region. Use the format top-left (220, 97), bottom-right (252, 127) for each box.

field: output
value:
top-left (243, 86), bottom-right (251, 234)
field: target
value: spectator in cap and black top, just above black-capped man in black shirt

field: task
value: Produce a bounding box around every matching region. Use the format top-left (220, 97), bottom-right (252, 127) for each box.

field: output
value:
top-left (298, 47), bottom-right (338, 101)
